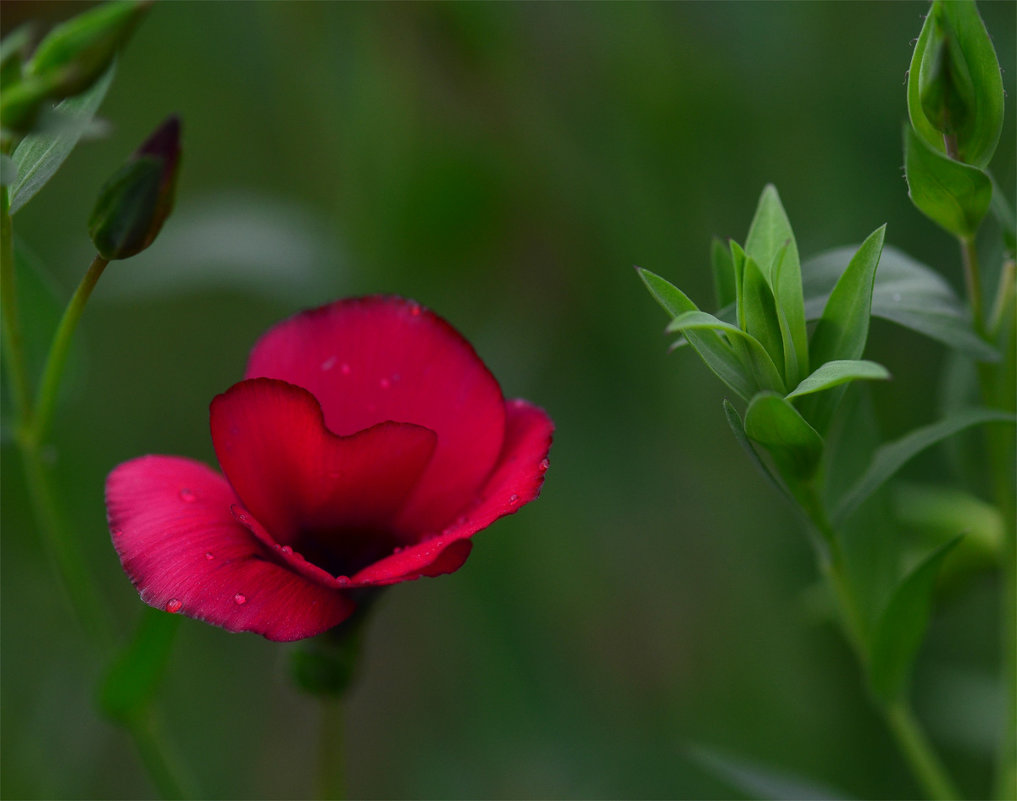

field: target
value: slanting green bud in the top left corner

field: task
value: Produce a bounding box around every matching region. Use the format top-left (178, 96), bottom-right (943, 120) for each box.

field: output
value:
top-left (26, 0), bottom-right (152, 99)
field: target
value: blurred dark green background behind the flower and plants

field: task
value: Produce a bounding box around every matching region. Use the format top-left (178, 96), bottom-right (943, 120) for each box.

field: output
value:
top-left (2, 2), bottom-right (1017, 798)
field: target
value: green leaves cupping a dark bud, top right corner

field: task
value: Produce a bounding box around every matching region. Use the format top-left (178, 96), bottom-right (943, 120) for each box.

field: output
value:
top-left (907, 0), bottom-right (1003, 167)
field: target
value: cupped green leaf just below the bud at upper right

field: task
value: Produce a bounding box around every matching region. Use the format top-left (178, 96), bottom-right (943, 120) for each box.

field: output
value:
top-left (904, 125), bottom-right (993, 239)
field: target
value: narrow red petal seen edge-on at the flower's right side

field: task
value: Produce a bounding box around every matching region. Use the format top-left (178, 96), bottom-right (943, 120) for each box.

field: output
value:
top-left (351, 401), bottom-right (554, 587)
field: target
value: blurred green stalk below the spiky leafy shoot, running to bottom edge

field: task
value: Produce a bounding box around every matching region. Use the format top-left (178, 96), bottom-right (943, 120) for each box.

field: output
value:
top-left (795, 482), bottom-right (960, 801)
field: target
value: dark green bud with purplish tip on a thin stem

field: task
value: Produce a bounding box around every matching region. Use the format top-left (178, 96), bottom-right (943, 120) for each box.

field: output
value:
top-left (88, 116), bottom-right (180, 261)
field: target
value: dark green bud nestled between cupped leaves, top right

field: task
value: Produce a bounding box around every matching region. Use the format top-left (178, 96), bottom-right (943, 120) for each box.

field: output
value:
top-left (918, 11), bottom-right (974, 136)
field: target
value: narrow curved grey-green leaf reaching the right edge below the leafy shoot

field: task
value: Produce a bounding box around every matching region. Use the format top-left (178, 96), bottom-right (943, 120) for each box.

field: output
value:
top-left (831, 409), bottom-right (1014, 527)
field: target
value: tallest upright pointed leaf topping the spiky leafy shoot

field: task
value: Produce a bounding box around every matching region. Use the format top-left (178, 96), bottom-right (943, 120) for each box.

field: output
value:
top-left (745, 184), bottom-right (809, 383)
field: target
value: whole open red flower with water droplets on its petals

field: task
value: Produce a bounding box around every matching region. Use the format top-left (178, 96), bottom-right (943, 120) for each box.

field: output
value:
top-left (106, 297), bottom-right (552, 640)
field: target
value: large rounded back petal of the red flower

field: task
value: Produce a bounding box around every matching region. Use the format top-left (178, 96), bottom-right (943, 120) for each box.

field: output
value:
top-left (245, 296), bottom-right (505, 535)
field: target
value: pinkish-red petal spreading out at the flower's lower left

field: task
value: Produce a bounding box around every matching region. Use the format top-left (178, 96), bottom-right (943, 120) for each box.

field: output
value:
top-left (106, 456), bottom-right (354, 640)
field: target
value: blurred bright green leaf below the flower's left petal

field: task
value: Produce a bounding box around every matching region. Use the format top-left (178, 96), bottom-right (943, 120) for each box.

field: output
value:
top-left (100, 607), bottom-right (181, 721)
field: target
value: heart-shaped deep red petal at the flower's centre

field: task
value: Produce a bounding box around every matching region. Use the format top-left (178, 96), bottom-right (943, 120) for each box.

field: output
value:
top-left (211, 378), bottom-right (435, 572)
